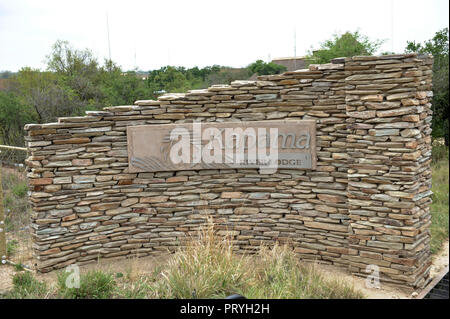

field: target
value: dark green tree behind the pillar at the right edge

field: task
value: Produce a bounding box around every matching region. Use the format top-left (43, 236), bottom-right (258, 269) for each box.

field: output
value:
top-left (405, 28), bottom-right (449, 146)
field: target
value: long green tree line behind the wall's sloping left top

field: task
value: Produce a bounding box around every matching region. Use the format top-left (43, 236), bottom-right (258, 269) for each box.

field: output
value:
top-left (0, 41), bottom-right (285, 145)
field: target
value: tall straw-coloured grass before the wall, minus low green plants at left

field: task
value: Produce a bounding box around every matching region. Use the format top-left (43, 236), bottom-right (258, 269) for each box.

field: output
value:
top-left (150, 223), bottom-right (363, 299)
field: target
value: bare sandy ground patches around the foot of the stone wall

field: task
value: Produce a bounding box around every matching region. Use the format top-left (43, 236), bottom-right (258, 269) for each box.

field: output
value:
top-left (0, 240), bottom-right (449, 299)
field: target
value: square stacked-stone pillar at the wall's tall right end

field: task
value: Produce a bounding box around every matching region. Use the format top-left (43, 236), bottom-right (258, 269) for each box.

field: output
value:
top-left (346, 55), bottom-right (433, 286)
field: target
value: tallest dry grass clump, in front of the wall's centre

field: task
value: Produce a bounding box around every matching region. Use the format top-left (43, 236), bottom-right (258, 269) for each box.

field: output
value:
top-left (153, 224), bottom-right (249, 299)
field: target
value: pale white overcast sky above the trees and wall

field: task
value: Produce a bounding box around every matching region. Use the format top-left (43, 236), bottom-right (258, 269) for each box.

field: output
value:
top-left (0, 0), bottom-right (449, 71)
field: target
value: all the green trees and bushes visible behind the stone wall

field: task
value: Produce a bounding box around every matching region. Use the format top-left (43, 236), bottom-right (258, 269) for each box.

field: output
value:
top-left (0, 28), bottom-right (449, 145)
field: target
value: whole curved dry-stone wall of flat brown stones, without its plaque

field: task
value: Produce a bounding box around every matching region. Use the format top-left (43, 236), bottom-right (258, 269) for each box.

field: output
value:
top-left (25, 54), bottom-right (433, 287)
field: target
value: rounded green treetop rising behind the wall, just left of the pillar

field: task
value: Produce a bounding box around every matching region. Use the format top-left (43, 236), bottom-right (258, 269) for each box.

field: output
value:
top-left (310, 31), bottom-right (385, 63)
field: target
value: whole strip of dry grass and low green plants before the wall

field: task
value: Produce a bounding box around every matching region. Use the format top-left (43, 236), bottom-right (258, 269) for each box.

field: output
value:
top-left (2, 222), bottom-right (364, 299)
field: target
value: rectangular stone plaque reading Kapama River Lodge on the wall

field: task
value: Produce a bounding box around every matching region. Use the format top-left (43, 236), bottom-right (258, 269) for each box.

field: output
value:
top-left (127, 120), bottom-right (317, 173)
